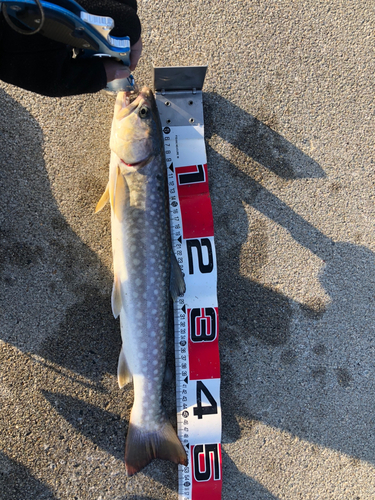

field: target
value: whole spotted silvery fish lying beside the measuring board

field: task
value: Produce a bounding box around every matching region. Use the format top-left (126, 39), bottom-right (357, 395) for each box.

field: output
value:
top-left (96, 87), bottom-right (187, 476)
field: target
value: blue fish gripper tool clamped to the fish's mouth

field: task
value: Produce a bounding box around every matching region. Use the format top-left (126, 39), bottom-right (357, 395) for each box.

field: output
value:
top-left (0, 0), bottom-right (135, 92)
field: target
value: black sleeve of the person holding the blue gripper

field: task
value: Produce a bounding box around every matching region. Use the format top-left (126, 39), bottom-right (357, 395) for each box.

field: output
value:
top-left (0, 0), bottom-right (141, 97)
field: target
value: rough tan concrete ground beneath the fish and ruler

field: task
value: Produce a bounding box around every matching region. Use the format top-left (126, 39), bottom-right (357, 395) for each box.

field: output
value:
top-left (0, 0), bottom-right (375, 500)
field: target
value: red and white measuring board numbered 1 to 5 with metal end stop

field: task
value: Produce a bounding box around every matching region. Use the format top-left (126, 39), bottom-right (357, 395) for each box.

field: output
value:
top-left (154, 66), bottom-right (222, 500)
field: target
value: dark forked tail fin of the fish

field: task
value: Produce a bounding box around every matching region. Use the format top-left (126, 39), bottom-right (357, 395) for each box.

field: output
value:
top-left (125, 420), bottom-right (187, 476)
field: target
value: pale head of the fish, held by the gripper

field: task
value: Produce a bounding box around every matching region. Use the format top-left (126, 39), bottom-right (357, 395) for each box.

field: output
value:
top-left (110, 87), bottom-right (161, 168)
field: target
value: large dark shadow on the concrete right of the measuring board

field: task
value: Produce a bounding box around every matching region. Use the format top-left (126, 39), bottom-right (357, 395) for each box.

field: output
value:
top-left (204, 94), bottom-right (375, 462)
